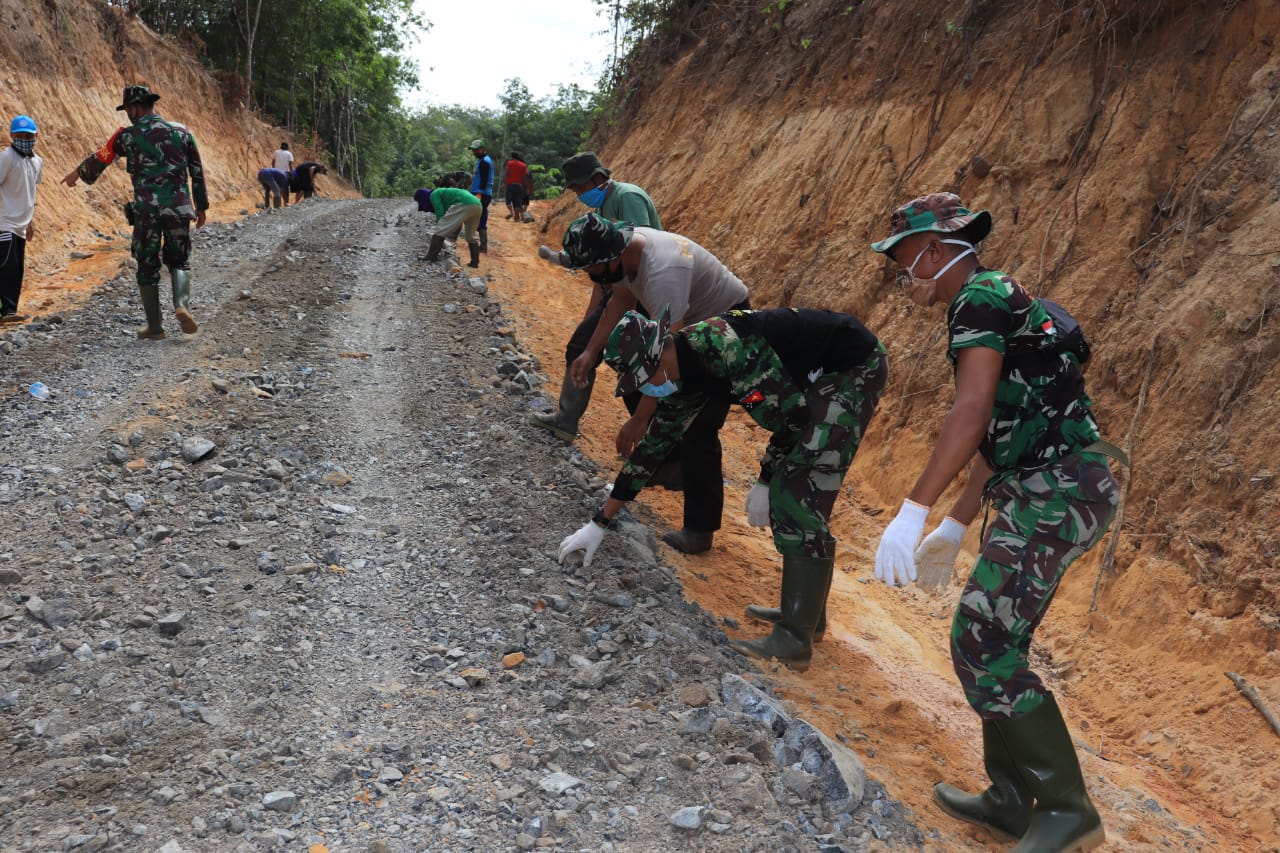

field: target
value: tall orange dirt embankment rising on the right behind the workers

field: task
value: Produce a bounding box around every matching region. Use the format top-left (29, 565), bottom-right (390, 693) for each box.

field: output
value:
top-left (514, 0), bottom-right (1280, 849)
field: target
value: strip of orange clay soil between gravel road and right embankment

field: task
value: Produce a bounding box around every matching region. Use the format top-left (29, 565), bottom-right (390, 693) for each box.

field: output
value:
top-left (481, 202), bottom-right (1280, 850)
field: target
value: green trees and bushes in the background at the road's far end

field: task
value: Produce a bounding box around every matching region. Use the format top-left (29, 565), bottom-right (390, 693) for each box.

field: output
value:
top-left (113, 0), bottom-right (599, 197)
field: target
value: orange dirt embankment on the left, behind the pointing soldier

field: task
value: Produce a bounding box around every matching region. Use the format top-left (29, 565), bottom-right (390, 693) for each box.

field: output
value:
top-left (0, 0), bottom-right (357, 310)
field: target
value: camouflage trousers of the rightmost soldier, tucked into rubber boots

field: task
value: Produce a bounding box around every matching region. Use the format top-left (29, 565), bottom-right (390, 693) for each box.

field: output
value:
top-left (951, 453), bottom-right (1119, 720)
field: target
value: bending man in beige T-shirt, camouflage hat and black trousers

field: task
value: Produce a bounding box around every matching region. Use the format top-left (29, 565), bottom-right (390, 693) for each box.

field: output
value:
top-left (550, 213), bottom-right (750, 553)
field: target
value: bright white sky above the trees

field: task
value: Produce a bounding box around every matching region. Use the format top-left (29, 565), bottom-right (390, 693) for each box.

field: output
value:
top-left (404, 0), bottom-right (613, 109)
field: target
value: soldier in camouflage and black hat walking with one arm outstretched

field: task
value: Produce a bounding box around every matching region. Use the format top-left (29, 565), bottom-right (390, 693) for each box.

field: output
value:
top-left (63, 86), bottom-right (209, 341)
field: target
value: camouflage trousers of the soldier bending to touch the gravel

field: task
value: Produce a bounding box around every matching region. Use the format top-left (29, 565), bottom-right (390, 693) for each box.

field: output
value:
top-left (769, 345), bottom-right (888, 557)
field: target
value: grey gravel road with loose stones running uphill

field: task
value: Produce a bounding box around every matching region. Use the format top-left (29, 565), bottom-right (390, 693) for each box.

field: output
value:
top-left (0, 200), bottom-right (936, 853)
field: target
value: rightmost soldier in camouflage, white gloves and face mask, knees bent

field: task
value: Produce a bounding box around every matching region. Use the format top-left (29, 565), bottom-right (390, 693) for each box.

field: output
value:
top-left (872, 193), bottom-right (1117, 853)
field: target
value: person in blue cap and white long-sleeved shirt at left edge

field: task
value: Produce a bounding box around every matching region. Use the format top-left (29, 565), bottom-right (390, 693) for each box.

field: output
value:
top-left (0, 115), bottom-right (44, 323)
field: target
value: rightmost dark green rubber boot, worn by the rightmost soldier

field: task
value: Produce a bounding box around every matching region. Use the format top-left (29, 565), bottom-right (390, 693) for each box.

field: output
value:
top-left (996, 693), bottom-right (1106, 853)
